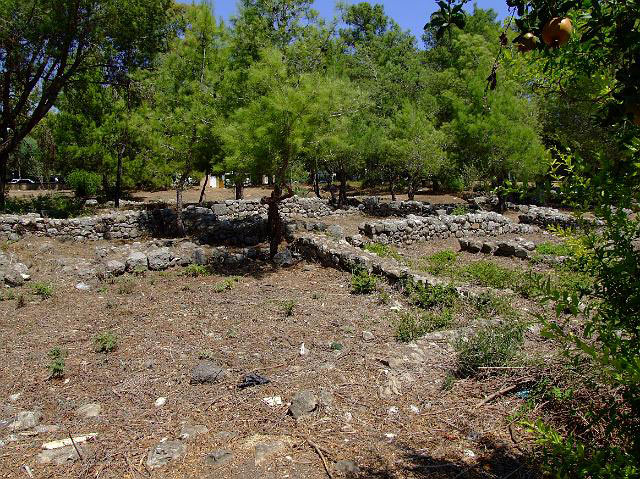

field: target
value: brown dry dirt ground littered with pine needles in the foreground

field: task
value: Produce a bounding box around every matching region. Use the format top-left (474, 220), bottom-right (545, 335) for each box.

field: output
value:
top-left (0, 230), bottom-right (545, 479)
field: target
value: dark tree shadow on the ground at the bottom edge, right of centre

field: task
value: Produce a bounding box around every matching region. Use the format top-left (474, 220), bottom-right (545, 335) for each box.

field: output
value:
top-left (352, 439), bottom-right (542, 479)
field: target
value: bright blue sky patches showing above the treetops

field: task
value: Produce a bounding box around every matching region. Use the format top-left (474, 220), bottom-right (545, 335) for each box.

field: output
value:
top-left (213, 0), bottom-right (507, 40)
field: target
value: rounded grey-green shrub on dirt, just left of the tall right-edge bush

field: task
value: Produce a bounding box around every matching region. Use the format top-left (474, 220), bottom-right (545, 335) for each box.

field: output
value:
top-left (454, 322), bottom-right (524, 376)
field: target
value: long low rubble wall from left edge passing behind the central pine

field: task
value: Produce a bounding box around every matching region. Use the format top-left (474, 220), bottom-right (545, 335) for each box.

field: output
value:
top-left (0, 197), bottom-right (359, 246)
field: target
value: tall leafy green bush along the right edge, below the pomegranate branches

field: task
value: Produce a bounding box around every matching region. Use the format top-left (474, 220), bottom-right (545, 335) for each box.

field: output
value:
top-left (529, 208), bottom-right (640, 478)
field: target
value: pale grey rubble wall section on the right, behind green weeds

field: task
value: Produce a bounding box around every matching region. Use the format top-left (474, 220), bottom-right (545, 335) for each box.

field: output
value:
top-left (360, 212), bottom-right (539, 244)
